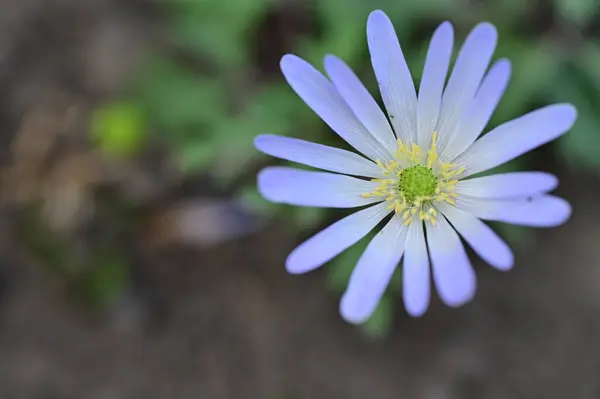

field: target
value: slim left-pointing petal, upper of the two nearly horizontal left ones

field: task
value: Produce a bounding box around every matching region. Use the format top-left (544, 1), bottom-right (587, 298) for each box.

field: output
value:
top-left (254, 134), bottom-right (382, 178)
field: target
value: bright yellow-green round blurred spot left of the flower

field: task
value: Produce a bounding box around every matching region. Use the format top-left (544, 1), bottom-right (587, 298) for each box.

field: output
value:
top-left (90, 101), bottom-right (146, 156)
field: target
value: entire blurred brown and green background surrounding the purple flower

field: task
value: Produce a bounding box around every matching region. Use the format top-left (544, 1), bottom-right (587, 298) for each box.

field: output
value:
top-left (0, 0), bottom-right (600, 399)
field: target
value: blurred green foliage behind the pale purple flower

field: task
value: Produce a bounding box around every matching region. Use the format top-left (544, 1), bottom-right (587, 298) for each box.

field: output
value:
top-left (89, 0), bottom-right (600, 337)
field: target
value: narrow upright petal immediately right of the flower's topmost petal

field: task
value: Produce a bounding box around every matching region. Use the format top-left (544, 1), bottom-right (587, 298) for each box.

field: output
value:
top-left (417, 22), bottom-right (454, 148)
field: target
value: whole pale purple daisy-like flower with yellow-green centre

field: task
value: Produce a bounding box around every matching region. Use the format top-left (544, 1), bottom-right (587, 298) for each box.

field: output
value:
top-left (255, 11), bottom-right (576, 323)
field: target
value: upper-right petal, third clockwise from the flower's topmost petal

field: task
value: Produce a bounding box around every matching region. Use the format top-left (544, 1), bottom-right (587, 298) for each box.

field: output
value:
top-left (444, 59), bottom-right (510, 159)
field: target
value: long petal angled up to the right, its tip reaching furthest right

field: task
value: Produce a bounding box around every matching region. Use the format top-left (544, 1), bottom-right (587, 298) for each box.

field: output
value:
top-left (453, 104), bottom-right (577, 177)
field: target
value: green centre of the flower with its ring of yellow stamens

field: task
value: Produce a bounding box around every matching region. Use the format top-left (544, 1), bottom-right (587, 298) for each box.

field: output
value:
top-left (362, 132), bottom-right (464, 225)
